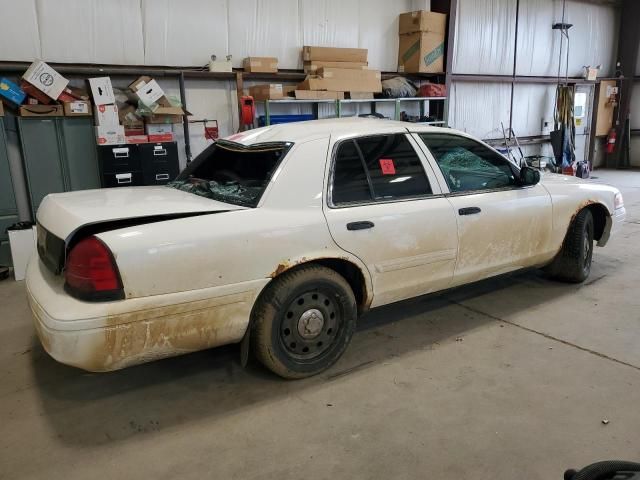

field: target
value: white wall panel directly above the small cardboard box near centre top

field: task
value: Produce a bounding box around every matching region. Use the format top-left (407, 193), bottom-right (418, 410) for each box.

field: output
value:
top-left (229, 0), bottom-right (302, 68)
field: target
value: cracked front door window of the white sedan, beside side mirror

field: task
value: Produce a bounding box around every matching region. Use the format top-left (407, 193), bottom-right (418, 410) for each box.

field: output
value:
top-left (420, 133), bottom-right (518, 192)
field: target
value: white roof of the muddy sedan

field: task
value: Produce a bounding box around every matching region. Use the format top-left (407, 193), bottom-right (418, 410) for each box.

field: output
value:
top-left (225, 117), bottom-right (465, 145)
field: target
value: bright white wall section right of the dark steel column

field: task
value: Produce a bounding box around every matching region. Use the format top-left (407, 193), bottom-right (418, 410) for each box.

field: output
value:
top-left (449, 0), bottom-right (619, 153)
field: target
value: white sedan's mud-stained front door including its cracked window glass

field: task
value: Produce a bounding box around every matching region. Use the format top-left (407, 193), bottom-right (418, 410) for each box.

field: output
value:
top-left (419, 133), bottom-right (553, 285)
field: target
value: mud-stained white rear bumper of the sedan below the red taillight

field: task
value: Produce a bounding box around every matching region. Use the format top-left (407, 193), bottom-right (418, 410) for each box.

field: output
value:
top-left (26, 258), bottom-right (268, 372)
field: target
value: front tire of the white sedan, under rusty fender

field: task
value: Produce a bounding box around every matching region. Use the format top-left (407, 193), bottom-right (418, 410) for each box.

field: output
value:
top-left (545, 208), bottom-right (593, 283)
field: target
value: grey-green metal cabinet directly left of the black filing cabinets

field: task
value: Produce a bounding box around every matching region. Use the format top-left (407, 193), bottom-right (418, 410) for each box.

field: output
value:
top-left (18, 117), bottom-right (100, 218)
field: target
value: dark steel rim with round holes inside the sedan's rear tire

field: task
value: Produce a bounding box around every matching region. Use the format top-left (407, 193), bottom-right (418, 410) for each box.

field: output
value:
top-left (280, 290), bottom-right (342, 361)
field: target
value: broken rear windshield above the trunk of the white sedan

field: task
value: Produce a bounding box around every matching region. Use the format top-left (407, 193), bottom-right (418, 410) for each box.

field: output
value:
top-left (167, 141), bottom-right (292, 207)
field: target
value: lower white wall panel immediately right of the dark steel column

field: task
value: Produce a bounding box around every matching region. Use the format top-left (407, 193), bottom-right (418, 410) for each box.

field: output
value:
top-left (449, 82), bottom-right (517, 138)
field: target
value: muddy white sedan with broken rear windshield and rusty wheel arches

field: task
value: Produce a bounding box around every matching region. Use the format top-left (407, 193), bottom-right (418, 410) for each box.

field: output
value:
top-left (26, 119), bottom-right (625, 378)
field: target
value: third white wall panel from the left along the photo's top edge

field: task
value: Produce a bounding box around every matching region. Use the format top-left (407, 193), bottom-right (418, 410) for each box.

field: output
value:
top-left (142, 0), bottom-right (229, 66)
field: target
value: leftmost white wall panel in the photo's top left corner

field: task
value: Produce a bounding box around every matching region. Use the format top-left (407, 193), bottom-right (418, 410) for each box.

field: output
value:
top-left (0, 0), bottom-right (41, 61)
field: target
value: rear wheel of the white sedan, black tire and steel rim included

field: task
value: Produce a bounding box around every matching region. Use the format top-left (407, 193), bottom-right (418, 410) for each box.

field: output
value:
top-left (251, 265), bottom-right (357, 379)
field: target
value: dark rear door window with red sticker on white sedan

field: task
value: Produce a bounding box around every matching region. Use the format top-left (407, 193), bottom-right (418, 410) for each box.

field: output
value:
top-left (332, 134), bottom-right (432, 205)
